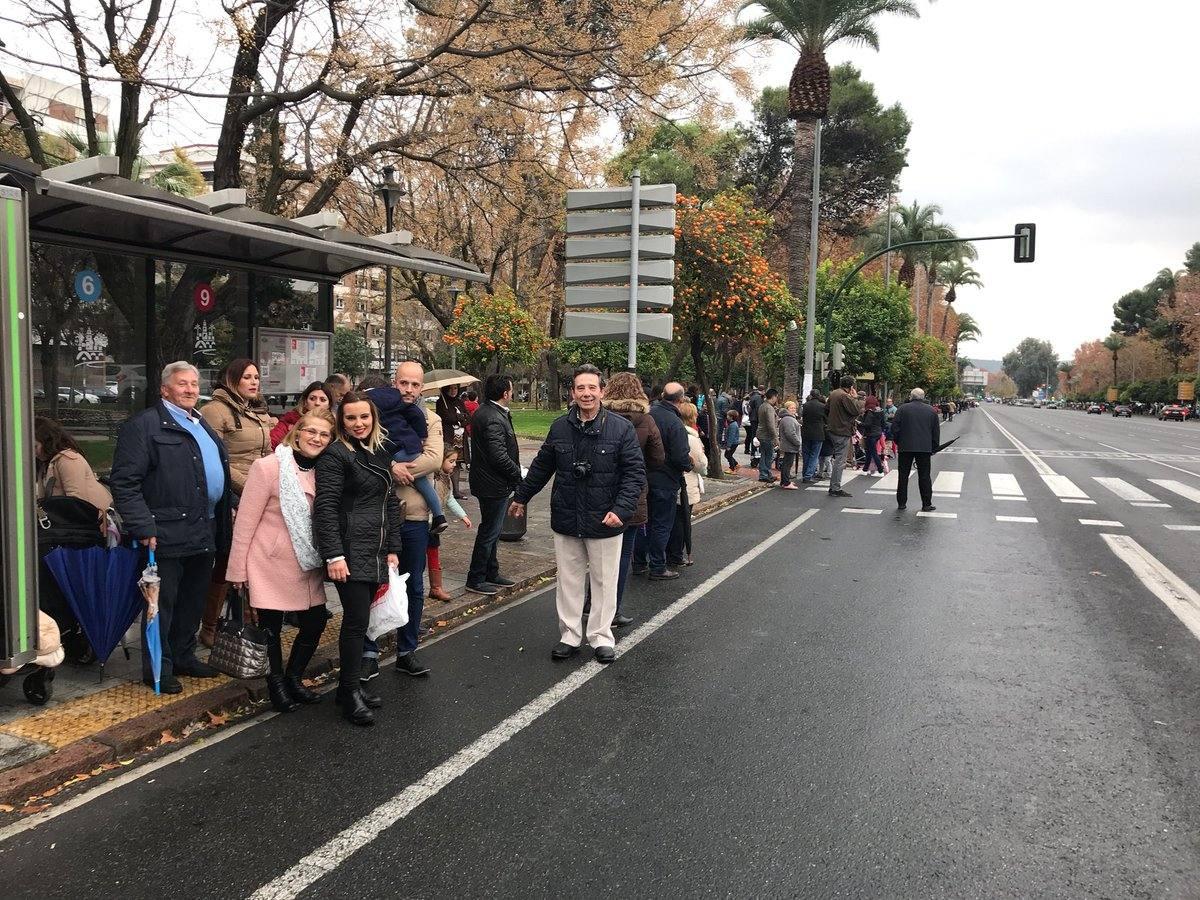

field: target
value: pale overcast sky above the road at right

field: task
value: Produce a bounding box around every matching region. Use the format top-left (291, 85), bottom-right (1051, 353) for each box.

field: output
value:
top-left (756, 0), bottom-right (1200, 359)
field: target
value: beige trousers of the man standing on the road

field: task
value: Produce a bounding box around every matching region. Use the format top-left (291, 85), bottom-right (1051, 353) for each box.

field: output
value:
top-left (554, 533), bottom-right (622, 647)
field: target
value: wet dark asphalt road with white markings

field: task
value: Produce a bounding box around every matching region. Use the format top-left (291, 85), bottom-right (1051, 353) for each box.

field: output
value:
top-left (0, 407), bottom-right (1200, 899)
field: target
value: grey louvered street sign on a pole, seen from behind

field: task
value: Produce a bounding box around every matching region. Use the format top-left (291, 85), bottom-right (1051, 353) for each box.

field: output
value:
top-left (563, 169), bottom-right (676, 368)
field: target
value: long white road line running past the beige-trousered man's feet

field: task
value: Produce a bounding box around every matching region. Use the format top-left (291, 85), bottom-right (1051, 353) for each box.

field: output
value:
top-left (251, 509), bottom-right (817, 900)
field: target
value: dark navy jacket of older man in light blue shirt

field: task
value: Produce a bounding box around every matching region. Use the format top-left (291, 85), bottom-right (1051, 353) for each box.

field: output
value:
top-left (108, 402), bottom-right (233, 557)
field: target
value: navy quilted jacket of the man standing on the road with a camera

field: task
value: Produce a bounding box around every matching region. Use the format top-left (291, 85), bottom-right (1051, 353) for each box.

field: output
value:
top-left (514, 409), bottom-right (648, 538)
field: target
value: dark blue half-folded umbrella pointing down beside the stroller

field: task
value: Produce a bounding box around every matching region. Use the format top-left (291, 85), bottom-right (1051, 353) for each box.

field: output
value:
top-left (46, 547), bottom-right (142, 664)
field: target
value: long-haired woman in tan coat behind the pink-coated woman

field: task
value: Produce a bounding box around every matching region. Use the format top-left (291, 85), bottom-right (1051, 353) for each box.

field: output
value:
top-left (200, 358), bottom-right (275, 647)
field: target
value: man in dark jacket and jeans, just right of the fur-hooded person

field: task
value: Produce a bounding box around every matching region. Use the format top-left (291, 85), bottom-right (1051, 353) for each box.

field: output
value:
top-left (634, 382), bottom-right (691, 581)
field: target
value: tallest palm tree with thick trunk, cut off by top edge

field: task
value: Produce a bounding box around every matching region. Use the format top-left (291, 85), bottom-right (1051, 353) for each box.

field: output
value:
top-left (742, 0), bottom-right (918, 388)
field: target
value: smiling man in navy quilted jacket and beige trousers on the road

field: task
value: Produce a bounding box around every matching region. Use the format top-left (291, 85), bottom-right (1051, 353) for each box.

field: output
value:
top-left (512, 366), bottom-right (646, 662)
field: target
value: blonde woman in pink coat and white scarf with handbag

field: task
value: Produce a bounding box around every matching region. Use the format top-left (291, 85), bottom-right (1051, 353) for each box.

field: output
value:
top-left (226, 409), bottom-right (335, 713)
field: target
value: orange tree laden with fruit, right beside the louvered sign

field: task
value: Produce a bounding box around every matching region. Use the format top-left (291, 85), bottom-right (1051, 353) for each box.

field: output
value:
top-left (673, 191), bottom-right (800, 474)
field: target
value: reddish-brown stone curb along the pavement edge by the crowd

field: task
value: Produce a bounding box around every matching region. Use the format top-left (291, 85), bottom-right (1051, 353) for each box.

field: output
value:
top-left (0, 482), bottom-right (770, 806)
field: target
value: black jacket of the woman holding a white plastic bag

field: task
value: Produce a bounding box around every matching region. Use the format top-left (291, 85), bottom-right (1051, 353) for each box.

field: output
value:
top-left (312, 440), bottom-right (404, 584)
